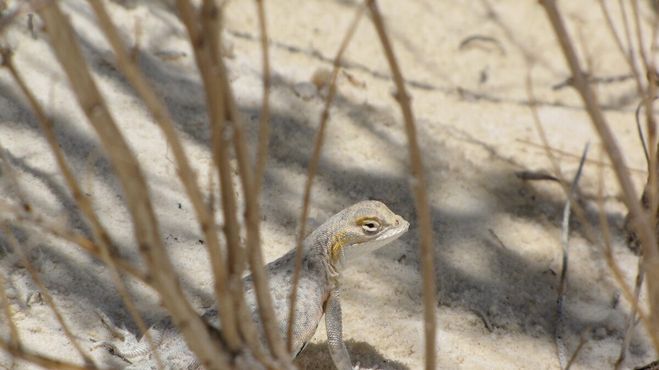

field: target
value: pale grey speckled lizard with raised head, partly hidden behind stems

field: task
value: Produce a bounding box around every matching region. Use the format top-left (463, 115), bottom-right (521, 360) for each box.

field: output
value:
top-left (95, 200), bottom-right (409, 370)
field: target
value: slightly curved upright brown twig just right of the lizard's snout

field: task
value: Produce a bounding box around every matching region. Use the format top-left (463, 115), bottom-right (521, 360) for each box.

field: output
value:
top-left (368, 0), bottom-right (437, 370)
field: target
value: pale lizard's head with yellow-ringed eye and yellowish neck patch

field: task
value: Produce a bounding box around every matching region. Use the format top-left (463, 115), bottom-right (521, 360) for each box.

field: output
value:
top-left (328, 200), bottom-right (410, 263)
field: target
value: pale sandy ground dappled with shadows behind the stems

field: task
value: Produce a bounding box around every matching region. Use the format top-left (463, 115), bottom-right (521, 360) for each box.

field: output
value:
top-left (0, 0), bottom-right (655, 369)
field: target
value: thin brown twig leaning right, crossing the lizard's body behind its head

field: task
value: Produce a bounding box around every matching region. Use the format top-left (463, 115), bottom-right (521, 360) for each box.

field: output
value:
top-left (286, 1), bottom-right (364, 352)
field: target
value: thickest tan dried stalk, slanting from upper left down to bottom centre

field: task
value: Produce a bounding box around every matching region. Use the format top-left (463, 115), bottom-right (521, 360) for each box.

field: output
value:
top-left (39, 2), bottom-right (232, 369)
